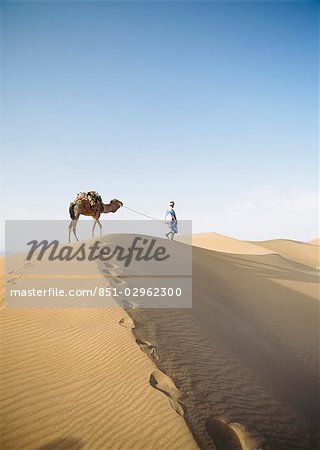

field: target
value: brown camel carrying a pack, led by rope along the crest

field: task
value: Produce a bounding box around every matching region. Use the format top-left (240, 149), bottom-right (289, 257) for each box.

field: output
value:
top-left (69, 192), bottom-right (123, 242)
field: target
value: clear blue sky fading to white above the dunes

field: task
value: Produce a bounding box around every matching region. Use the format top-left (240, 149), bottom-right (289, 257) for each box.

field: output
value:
top-left (0, 1), bottom-right (319, 246)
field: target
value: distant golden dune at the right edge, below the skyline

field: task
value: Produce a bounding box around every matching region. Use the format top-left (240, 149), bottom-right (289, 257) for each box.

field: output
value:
top-left (253, 239), bottom-right (320, 267)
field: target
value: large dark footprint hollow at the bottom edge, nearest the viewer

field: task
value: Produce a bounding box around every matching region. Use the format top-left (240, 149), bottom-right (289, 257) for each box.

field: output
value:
top-left (206, 417), bottom-right (242, 450)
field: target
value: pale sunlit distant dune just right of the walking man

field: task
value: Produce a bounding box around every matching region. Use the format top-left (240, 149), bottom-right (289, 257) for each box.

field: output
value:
top-left (179, 233), bottom-right (274, 255)
